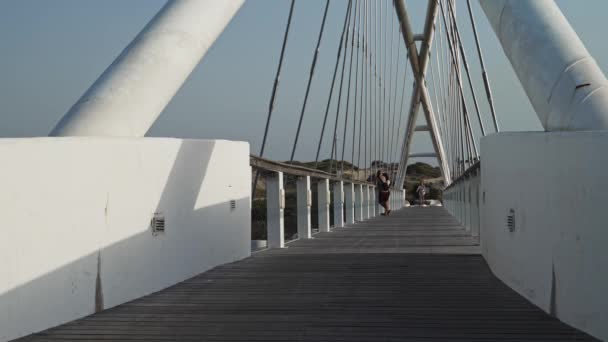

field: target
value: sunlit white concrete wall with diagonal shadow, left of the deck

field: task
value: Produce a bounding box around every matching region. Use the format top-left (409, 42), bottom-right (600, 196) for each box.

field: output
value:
top-left (0, 138), bottom-right (251, 341)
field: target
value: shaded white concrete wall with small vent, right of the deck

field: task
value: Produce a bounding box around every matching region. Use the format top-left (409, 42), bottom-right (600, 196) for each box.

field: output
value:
top-left (481, 132), bottom-right (608, 340)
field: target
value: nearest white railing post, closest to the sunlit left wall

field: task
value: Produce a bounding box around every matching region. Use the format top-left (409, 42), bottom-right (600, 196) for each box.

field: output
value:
top-left (266, 172), bottom-right (285, 248)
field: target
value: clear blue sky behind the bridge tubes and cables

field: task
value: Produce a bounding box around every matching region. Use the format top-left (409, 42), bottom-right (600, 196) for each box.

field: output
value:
top-left (0, 0), bottom-right (608, 164)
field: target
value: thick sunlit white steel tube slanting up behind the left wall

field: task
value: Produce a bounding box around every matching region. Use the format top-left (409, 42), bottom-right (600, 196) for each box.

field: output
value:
top-left (51, 0), bottom-right (244, 137)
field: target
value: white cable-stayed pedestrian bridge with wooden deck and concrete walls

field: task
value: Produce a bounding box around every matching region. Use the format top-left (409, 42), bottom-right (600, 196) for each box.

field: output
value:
top-left (0, 0), bottom-right (608, 341)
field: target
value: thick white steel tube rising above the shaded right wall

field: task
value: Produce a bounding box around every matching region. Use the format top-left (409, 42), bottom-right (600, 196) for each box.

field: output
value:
top-left (479, 0), bottom-right (608, 131)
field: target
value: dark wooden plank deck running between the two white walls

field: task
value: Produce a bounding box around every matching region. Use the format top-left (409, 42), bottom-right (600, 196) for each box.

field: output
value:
top-left (23, 208), bottom-right (594, 341)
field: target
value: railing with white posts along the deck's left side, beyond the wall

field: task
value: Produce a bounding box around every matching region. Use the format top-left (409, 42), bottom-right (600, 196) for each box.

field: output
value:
top-left (250, 156), bottom-right (405, 248)
